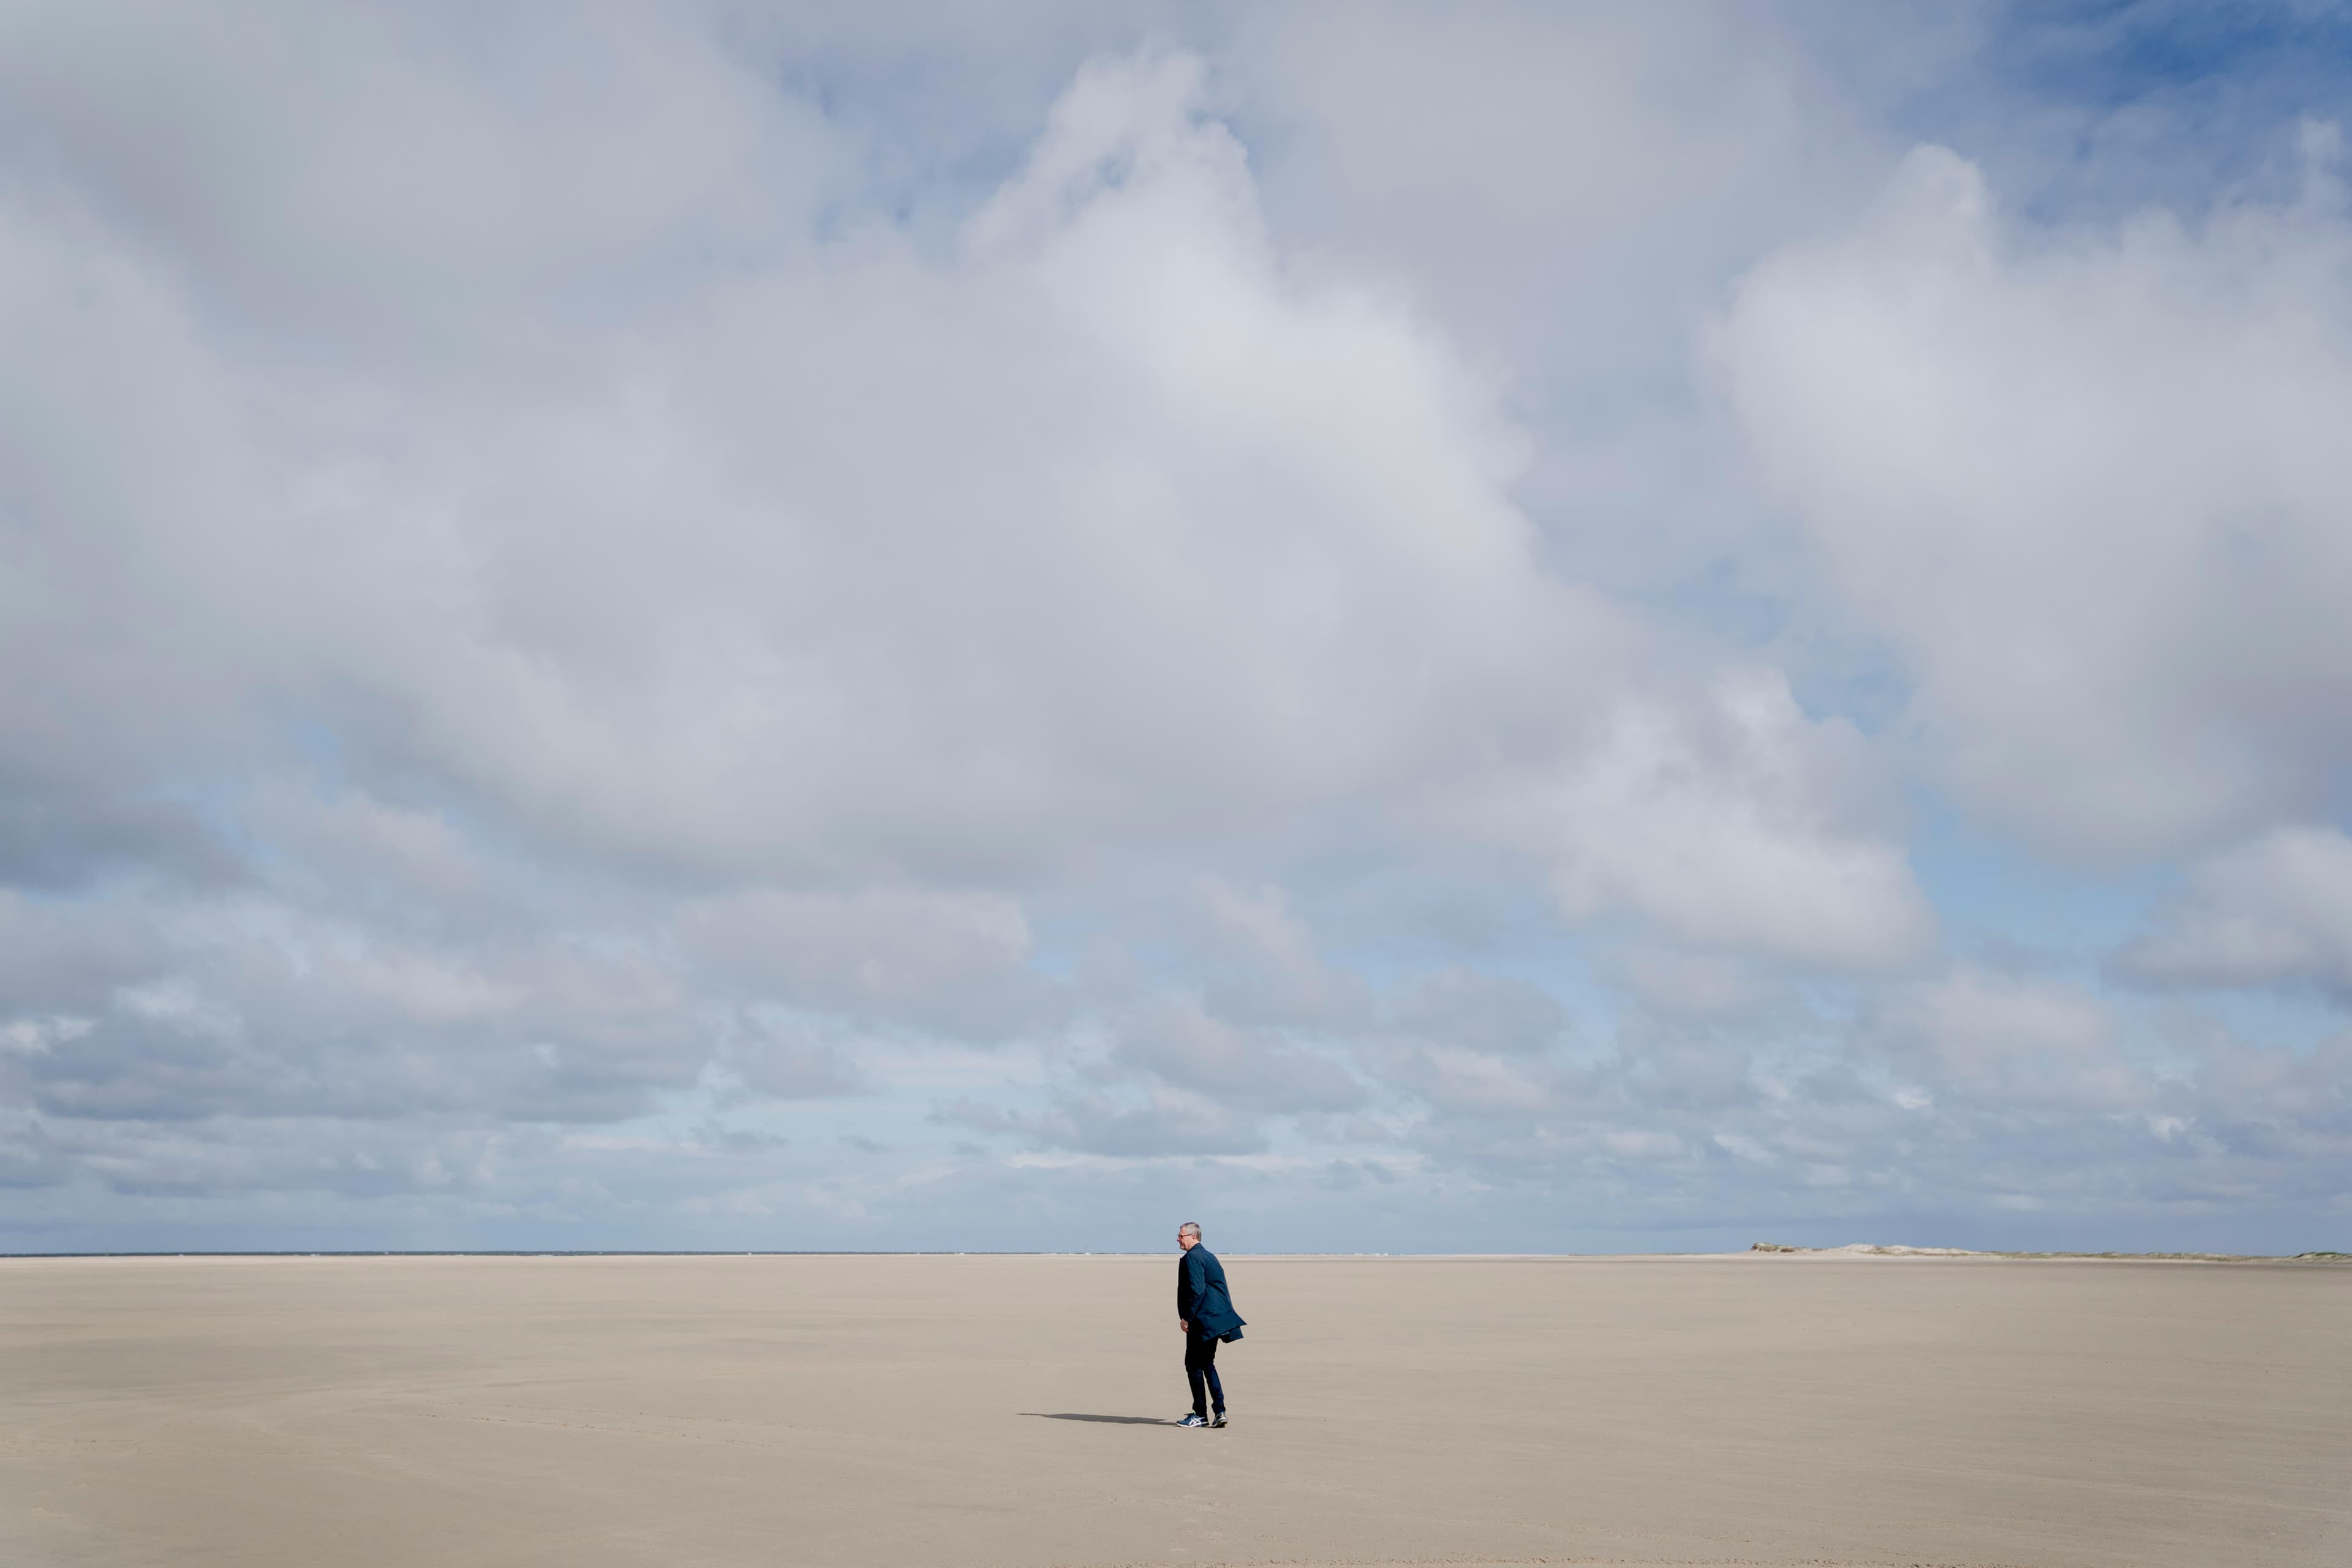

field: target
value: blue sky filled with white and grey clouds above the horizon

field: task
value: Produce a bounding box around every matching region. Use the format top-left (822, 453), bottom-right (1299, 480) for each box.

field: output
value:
top-left (0, 0), bottom-right (2352, 1253)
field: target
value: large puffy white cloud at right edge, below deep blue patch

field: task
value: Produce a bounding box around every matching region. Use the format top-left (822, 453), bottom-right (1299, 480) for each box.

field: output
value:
top-left (1714, 132), bottom-right (2352, 858)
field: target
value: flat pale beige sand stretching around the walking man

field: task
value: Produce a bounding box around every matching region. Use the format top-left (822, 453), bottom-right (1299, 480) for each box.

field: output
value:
top-left (0, 1257), bottom-right (2352, 1568)
